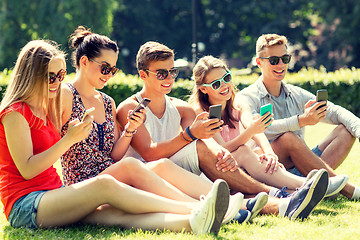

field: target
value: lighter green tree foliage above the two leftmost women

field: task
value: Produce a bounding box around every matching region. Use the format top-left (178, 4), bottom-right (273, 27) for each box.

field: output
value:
top-left (0, 0), bottom-right (117, 69)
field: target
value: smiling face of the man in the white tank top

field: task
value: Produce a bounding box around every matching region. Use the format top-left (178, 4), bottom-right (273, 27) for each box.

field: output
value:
top-left (139, 57), bottom-right (175, 94)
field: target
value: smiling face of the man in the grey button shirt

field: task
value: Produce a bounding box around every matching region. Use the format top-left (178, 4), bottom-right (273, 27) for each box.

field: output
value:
top-left (256, 45), bottom-right (288, 83)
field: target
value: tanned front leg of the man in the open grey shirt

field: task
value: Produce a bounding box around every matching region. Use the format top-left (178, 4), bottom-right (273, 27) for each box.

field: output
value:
top-left (271, 132), bottom-right (355, 198)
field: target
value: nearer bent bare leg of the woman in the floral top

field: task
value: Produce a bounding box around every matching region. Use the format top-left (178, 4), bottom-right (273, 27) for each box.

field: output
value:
top-left (101, 158), bottom-right (197, 202)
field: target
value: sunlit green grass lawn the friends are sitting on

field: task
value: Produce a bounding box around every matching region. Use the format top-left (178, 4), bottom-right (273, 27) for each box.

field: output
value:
top-left (0, 124), bottom-right (360, 240)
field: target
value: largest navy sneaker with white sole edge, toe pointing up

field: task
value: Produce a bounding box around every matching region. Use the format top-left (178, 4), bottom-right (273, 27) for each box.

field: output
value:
top-left (285, 169), bottom-right (329, 220)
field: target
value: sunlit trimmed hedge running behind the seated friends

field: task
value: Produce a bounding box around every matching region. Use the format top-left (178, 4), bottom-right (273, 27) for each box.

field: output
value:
top-left (0, 68), bottom-right (360, 116)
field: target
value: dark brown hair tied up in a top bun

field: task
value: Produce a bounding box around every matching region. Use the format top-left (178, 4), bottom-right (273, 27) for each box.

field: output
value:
top-left (69, 26), bottom-right (119, 68)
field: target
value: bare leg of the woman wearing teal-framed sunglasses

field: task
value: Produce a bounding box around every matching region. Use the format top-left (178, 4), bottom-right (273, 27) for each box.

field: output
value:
top-left (231, 146), bottom-right (305, 190)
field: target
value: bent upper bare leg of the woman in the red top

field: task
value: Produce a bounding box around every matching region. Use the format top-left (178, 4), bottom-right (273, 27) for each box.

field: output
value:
top-left (36, 175), bottom-right (194, 227)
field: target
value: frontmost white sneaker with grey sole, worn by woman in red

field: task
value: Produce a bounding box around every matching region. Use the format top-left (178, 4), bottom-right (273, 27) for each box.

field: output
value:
top-left (189, 179), bottom-right (230, 235)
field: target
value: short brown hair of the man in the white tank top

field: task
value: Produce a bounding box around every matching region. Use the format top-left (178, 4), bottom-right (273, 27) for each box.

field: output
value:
top-left (136, 41), bottom-right (175, 71)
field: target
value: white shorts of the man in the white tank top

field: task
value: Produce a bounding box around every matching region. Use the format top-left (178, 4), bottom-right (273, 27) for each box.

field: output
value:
top-left (169, 141), bottom-right (201, 175)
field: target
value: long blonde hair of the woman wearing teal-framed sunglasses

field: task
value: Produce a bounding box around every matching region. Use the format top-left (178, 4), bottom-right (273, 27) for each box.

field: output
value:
top-left (189, 56), bottom-right (236, 128)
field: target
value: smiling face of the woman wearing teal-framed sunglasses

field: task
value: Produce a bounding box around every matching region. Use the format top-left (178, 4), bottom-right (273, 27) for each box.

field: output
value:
top-left (200, 68), bottom-right (233, 105)
